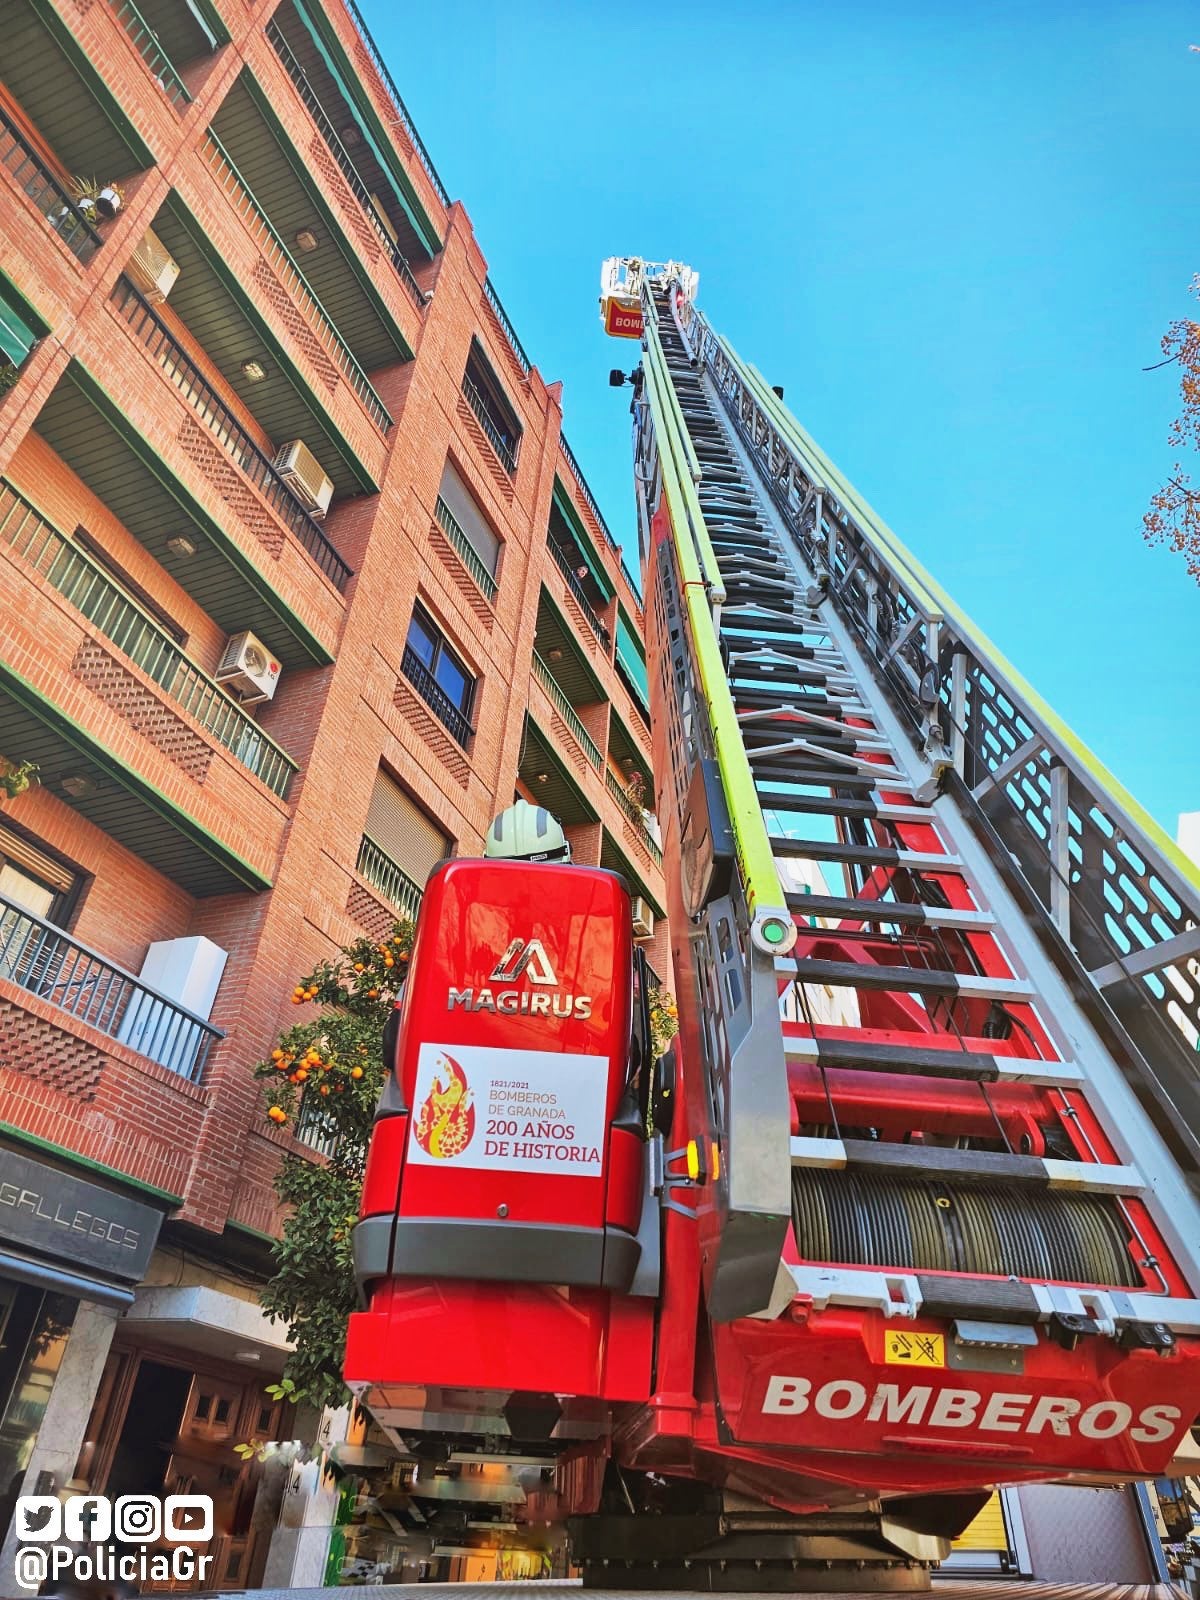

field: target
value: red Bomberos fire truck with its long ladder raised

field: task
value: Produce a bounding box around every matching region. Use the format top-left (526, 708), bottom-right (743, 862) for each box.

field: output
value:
top-left (346, 258), bottom-right (1200, 1590)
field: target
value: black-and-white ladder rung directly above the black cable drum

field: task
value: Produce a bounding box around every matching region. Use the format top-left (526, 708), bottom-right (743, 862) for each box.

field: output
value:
top-left (792, 1136), bottom-right (1146, 1195)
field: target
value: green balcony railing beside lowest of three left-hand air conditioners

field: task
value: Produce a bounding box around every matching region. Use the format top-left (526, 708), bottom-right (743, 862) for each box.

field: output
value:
top-left (0, 478), bottom-right (296, 798)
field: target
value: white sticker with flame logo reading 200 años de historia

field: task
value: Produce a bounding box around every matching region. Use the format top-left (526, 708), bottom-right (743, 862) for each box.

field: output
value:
top-left (408, 1045), bottom-right (608, 1178)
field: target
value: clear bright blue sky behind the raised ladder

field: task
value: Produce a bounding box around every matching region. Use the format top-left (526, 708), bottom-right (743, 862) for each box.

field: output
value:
top-left (369, 0), bottom-right (1200, 834)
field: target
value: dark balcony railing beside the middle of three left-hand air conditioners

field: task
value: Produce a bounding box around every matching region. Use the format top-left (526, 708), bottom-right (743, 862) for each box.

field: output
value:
top-left (112, 278), bottom-right (352, 592)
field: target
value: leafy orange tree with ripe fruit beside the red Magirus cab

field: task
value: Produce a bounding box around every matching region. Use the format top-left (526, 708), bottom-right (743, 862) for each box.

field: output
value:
top-left (254, 922), bottom-right (413, 1406)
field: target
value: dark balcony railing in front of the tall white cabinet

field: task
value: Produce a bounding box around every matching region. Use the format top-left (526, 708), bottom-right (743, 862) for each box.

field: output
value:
top-left (0, 896), bottom-right (226, 1083)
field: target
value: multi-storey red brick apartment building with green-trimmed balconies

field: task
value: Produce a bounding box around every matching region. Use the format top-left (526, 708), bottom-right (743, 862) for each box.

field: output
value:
top-left (0, 0), bottom-right (666, 1587)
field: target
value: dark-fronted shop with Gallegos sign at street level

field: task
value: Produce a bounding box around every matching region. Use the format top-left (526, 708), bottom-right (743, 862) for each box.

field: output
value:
top-left (0, 1149), bottom-right (162, 1544)
